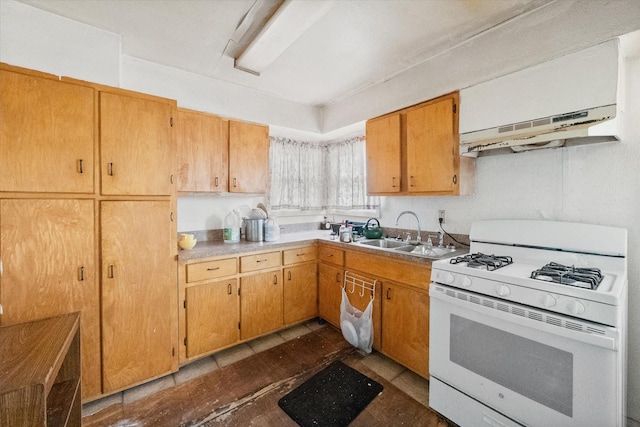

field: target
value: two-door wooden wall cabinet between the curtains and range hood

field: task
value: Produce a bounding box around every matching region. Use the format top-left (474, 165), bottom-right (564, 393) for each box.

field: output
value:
top-left (367, 92), bottom-right (475, 195)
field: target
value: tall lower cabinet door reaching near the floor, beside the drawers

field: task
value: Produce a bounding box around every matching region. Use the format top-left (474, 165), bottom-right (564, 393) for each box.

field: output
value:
top-left (101, 201), bottom-right (178, 393)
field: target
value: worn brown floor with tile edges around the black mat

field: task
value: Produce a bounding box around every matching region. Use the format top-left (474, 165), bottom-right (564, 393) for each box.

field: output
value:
top-left (82, 320), bottom-right (447, 427)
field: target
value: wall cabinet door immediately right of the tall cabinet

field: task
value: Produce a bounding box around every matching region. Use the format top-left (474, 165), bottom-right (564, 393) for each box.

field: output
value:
top-left (176, 110), bottom-right (229, 193)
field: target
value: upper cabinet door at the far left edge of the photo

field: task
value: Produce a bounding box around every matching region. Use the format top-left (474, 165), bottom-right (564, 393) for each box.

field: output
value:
top-left (0, 71), bottom-right (95, 193)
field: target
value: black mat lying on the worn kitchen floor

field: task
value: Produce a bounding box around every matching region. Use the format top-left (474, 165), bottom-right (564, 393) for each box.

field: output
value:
top-left (278, 361), bottom-right (382, 427)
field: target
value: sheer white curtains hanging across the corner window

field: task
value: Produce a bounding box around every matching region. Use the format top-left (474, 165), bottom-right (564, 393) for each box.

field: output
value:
top-left (270, 137), bottom-right (379, 211)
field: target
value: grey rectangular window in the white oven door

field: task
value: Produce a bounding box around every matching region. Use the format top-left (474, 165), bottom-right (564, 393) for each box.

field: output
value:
top-left (449, 314), bottom-right (573, 417)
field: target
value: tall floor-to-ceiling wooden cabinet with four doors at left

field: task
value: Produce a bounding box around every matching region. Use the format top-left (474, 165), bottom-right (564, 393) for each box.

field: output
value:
top-left (0, 64), bottom-right (178, 401)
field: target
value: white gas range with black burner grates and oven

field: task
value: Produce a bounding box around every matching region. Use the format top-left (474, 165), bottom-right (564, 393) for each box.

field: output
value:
top-left (429, 220), bottom-right (627, 427)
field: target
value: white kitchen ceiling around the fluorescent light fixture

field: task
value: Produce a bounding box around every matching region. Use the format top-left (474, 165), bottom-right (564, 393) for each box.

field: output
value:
top-left (20, 0), bottom-right (553, 106)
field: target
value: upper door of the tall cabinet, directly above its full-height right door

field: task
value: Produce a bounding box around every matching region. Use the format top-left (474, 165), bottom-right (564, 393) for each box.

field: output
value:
top-left (100, 92), bottom-right (173, 196)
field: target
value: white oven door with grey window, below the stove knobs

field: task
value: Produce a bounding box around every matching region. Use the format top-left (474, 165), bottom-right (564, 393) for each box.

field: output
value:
top-left (429, 283), bottom-right (624, 427)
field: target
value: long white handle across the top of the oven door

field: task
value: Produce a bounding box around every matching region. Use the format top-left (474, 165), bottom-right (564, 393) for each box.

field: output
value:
top-left (429, 283), bottom-right (620, 351)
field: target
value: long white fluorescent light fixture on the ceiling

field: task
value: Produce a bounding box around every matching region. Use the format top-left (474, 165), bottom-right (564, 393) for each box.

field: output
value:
top-left (234, 0), bottom-right (334, 76)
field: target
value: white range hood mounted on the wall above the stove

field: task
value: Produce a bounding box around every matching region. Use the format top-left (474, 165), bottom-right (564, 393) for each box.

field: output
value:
top-left (460, 40), bottom-right (621, 156)
